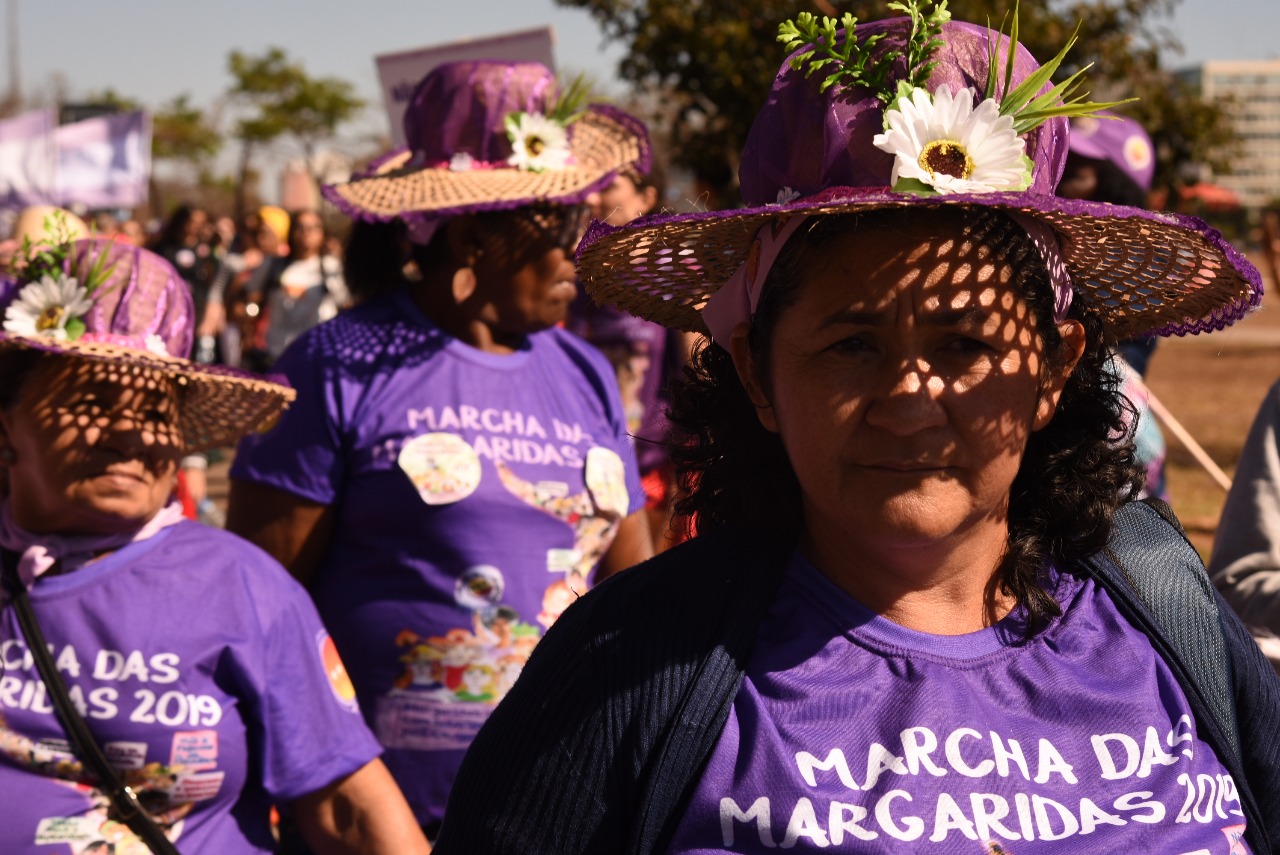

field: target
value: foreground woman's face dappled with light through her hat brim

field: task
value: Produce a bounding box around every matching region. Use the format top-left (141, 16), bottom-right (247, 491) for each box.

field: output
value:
top-left (735, 218), bottom-right (1083, 548)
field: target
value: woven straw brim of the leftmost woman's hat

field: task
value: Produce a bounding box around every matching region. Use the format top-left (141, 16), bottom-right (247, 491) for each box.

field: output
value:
top-left (0, 335), bottom-right (297, 452)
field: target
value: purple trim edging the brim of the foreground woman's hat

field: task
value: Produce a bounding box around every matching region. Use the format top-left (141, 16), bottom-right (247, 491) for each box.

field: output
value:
top-left (575, 187), bottom-right (1262, 337)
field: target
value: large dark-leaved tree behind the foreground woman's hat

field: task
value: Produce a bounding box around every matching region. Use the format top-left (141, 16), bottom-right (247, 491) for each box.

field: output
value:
top-left (556, 0), bottom-right (1230, 202)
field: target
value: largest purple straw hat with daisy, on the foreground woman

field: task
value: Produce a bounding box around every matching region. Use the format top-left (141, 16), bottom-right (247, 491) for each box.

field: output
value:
top-left (577, 0), bottom-right (1262, 340)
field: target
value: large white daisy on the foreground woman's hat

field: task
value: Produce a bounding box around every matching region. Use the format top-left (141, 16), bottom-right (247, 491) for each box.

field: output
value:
top-left (872, 86), bottom-right (1030, 193)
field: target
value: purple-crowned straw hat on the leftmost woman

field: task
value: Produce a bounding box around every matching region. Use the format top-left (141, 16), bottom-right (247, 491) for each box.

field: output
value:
top-left (0, 239), bottom-right (294, 451)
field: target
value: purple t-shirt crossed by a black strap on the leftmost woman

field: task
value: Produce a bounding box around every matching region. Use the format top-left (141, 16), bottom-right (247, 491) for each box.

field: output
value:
top-left (0, 522), bottom-right (379, 855)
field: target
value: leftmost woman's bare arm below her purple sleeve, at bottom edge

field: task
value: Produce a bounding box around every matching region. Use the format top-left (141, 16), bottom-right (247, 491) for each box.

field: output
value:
top-left (291, 759), bottom-right (431, 855)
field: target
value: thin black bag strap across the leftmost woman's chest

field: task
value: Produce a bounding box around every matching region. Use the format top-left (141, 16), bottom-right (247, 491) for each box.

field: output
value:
top-left (3, 549), bottom-right (180, 855)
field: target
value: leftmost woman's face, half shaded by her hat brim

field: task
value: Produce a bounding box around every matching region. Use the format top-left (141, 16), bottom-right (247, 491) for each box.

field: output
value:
top-left (0, 357), bottom-right (183, 534)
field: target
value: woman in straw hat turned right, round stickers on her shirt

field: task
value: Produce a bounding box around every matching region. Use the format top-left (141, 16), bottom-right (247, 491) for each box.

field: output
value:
top-left (229, 61), bottom-right (650, 833)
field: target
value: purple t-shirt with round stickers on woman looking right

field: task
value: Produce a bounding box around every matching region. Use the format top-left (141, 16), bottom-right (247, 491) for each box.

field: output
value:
top-left (232, 294), bottom-right (644, 823)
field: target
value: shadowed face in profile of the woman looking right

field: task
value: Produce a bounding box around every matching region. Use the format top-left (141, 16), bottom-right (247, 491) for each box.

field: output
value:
top-left (474, 207), bottom-right (586, 335)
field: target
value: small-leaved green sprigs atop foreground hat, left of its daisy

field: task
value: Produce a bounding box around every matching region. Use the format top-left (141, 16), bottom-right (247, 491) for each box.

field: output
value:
top-left (777, 0), bottom-right (951, 105)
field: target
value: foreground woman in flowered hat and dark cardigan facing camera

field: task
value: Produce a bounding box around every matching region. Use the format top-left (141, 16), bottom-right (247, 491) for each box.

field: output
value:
top-left (436, 0), bottom-right (1280, 855)
